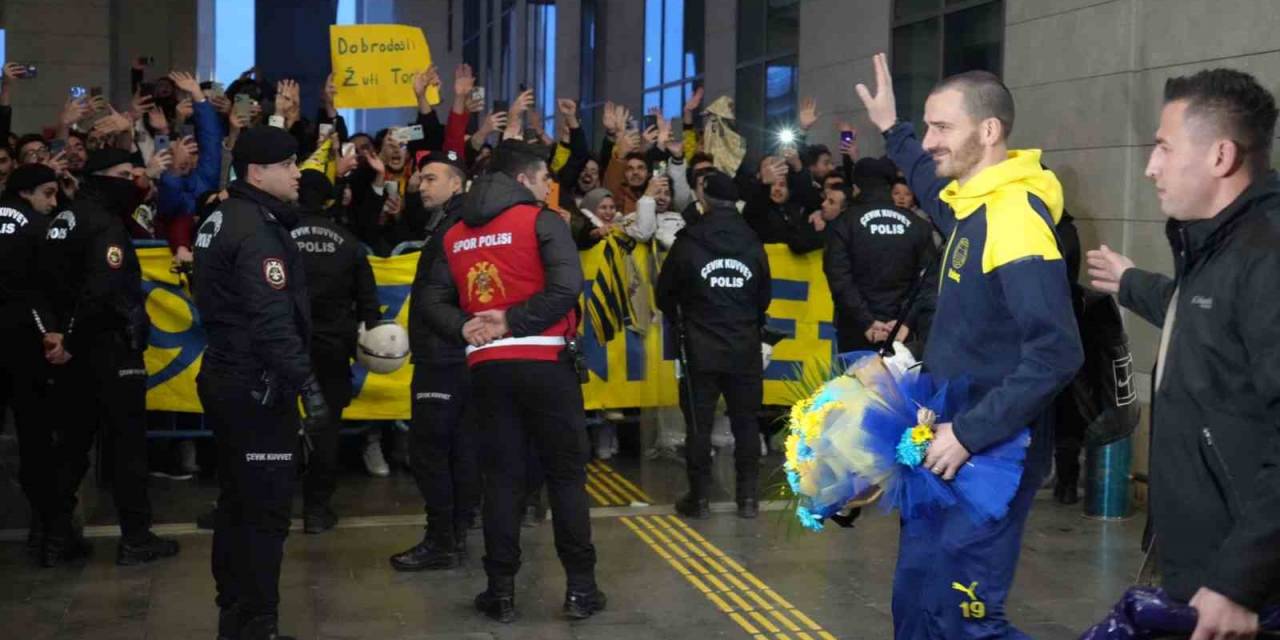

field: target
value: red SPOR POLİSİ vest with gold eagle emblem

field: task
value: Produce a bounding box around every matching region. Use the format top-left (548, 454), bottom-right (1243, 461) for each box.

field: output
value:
top-left (444, 205), bottom-right (577, 366)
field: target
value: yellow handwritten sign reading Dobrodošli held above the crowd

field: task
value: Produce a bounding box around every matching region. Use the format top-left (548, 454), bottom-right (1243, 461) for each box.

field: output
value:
top-left (329, 24), bottom-right (440, 109)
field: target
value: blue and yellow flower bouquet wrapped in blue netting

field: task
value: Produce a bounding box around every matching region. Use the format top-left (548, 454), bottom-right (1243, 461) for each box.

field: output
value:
top-left (783, 355), bottom-right (1030, 531)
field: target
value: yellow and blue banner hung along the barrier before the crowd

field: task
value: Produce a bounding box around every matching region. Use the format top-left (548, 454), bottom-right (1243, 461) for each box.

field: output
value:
top-left (138, 243), bottom-right (836, 420)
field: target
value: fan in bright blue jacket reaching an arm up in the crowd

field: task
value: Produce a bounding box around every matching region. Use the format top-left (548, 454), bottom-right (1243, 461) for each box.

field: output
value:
top-left (156, 72), bottom-right (223, 262)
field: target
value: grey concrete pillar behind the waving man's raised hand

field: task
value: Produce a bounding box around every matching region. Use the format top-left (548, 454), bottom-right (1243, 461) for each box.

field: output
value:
top-left (799, 0), bottom-right (893, 156)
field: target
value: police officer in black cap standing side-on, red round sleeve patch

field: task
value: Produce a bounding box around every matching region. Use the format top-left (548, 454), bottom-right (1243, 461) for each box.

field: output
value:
top-left (195, 125), bottom-right (330, 640)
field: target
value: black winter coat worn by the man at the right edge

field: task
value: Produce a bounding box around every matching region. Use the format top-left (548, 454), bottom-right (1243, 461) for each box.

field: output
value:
top-left (1120, 173), bottom-right (1280, 611)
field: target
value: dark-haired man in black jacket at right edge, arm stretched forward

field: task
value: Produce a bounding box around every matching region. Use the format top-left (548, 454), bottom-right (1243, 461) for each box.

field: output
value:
top-left (1088, 69), bottom-right (1280, 640)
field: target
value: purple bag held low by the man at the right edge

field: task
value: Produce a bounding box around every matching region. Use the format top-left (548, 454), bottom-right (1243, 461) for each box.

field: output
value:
top-left (1080, 586), bottom-right (1280, 640)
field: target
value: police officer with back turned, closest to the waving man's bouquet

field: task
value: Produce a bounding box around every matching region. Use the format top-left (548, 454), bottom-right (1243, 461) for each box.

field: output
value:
top-left (822, 159), bottom-right (937, 353)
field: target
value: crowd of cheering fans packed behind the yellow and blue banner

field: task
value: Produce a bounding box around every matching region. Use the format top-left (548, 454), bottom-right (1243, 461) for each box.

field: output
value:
top-left (0, 60), bottom-right (924, 475)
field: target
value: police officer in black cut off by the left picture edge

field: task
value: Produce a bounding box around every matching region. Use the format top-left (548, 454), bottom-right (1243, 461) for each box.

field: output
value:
top-left (0, 164), bottom-right (58, 552)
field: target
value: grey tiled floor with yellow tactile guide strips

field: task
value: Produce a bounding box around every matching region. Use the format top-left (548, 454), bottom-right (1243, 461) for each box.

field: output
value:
top-left (0, 422), bottom-right (1142, 640)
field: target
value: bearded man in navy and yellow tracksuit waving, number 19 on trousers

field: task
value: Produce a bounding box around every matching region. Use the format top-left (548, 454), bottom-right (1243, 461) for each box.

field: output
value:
top-left (858, 54), bottom-right (1084, 640)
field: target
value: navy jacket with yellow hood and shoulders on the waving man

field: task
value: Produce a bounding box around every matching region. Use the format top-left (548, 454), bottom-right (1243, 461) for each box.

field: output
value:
top-left (884, 123), bottom-right (1084, 467)
